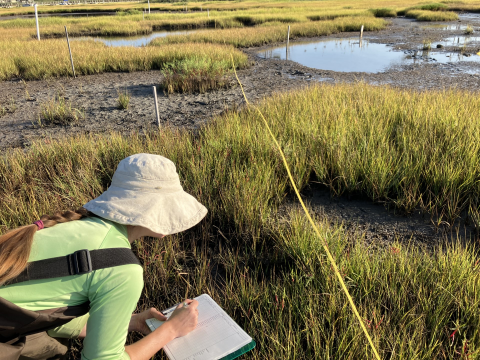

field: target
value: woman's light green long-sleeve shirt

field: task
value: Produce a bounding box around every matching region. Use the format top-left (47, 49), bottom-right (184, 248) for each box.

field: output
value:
top-left (0, 217), bottom-right (143, 360)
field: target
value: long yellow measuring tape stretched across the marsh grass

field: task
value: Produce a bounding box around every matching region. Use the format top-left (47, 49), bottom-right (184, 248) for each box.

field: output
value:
top-left (230, 55), bottom-right (381, 360)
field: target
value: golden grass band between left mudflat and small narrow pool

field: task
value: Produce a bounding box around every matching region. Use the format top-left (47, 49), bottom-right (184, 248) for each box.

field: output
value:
top-left (0, 39), bottom-right (247, 80)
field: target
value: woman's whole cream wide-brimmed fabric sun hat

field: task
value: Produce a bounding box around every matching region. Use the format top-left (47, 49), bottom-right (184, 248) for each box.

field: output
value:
top-left (84, 154), bottom-right (207, 235)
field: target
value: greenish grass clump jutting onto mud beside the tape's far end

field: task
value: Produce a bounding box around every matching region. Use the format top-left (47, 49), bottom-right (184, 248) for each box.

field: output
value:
top-left (162, 57), bottom-right (230, 94)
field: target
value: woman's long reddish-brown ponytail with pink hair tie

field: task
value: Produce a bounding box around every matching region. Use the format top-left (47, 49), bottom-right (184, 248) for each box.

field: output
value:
top-left (0, 208), bottom-right (90, 285)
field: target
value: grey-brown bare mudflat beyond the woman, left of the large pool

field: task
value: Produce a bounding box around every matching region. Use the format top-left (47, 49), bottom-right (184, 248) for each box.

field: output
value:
top-left (0, 61), bottom-right (308, 149)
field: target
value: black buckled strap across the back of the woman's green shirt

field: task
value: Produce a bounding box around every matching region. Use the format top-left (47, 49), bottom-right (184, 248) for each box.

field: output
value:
top-left (7, 248), bottom-right (140, 285)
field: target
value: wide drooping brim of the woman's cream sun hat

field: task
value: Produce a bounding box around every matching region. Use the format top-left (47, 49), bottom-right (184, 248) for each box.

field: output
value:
top-left (84, 186), bottom-right (208, 235)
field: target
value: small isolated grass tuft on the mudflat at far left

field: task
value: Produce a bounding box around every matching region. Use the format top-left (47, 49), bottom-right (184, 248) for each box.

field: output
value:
top-left (39, 95), bottom-right (85, 125)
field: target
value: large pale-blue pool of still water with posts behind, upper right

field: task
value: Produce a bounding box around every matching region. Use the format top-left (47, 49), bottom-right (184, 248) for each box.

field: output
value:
top-left (258, 38), bottom-right (480, 73)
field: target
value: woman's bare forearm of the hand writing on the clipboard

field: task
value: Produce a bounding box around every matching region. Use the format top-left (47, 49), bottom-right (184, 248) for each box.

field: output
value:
top-left (125, 322), bottom-right (176, 360)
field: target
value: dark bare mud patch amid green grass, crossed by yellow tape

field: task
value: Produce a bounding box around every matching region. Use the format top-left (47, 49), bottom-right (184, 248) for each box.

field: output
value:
top-left (277, 183), bottom-right (478, 249)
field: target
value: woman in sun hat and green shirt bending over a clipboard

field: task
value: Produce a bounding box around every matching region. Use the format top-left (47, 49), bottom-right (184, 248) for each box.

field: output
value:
top-left (0, 154), bottom-right (207, 360)
